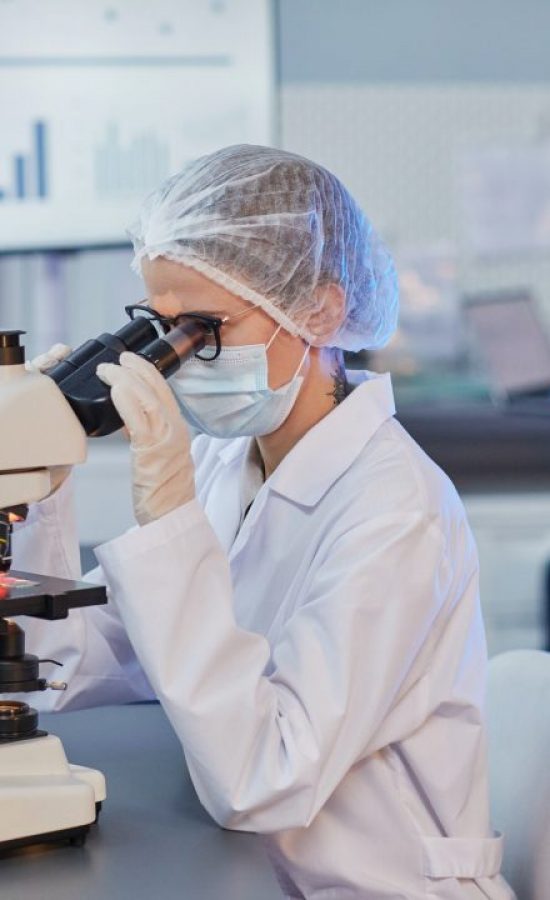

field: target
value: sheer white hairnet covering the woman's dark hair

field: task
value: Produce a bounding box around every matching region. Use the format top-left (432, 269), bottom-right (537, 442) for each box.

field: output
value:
top-left (129, 144), bottom-right (398, 350)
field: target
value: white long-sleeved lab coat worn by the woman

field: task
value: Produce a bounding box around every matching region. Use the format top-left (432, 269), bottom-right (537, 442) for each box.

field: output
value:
top-left (12, 376), bottom-right (513, 900)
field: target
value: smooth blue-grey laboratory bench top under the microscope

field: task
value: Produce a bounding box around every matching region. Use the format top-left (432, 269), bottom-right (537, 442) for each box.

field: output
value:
top-left (0, 703), bottom-right (281, 900)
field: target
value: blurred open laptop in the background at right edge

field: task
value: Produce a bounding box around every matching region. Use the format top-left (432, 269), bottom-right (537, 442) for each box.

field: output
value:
top-left (464, 290), bottom-right (550, 416)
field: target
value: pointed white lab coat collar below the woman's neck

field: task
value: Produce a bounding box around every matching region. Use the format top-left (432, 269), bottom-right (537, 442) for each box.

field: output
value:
top-left (218, 371), bottom-right (395, 506)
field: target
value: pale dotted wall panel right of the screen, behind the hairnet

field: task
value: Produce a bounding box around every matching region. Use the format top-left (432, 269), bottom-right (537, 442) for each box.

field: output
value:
top-left (281, 83), bottom-right (550, 326)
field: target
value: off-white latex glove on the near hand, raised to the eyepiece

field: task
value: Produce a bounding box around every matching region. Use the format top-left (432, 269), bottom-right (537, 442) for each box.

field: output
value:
top-left (97, 353), bottom-right (195, 525)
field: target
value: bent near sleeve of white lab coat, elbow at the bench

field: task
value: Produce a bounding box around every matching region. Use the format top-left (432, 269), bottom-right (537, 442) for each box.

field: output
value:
top-left (97, 501), bottom-right (447, 832)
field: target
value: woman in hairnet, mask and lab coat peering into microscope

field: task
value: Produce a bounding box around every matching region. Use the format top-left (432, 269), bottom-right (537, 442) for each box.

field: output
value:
top-left (16, 146), bottom-right (513, 900)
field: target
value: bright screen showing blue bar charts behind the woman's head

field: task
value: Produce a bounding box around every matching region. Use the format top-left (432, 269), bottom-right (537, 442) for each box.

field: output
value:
top-left (0, 0), bottom-right (274, 253)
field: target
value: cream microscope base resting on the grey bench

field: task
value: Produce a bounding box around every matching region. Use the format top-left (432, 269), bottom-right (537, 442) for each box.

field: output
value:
top-left (0, 734), bottom-right (106, 851)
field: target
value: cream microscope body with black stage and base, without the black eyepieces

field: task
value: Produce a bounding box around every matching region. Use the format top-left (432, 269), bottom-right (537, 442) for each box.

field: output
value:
top-left (0, 334), bottom-right (106, 851)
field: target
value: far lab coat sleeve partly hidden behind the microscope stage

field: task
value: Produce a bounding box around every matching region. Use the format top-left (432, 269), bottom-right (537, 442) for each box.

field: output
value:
top-left (9, 479), bottom-right (154, 712)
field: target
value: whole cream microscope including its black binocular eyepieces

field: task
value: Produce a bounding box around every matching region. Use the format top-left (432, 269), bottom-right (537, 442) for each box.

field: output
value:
top-left (0, 317), bottom-right (207, 852)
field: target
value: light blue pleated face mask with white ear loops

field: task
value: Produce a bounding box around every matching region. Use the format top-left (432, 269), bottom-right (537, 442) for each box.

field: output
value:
top-left (168, 328), bottom-right (309, 438)
